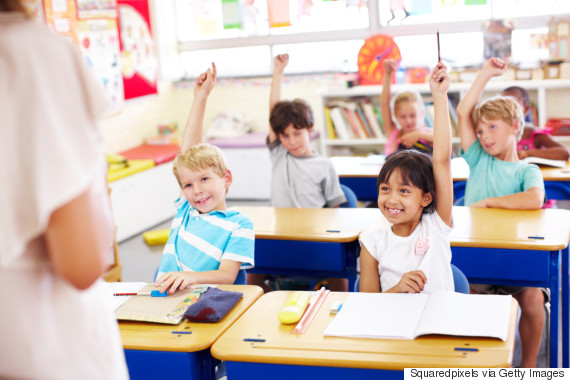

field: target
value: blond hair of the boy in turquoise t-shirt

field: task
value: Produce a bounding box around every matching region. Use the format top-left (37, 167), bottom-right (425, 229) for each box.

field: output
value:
top-left (471, 96), bottom-right (525, 141)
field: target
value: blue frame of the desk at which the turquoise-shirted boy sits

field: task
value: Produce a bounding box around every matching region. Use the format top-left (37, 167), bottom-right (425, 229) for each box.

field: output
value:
top-left (451, 246), bottom-right (570, 368)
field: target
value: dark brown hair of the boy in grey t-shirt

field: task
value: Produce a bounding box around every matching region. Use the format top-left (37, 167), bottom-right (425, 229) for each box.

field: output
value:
top-left (269, 99), bottom-right (315, 136)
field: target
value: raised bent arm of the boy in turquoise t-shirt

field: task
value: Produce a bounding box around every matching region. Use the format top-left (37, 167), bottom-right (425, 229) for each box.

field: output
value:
top-left (457, 58), bottom-right (507, 150)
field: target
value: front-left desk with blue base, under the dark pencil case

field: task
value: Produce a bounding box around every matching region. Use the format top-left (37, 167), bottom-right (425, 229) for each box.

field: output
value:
top-left (119, 285), bottom-right (263, 380)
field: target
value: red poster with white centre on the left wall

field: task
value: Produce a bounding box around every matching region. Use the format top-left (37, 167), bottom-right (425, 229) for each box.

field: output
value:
top-left (118, 0), bottom-right (158, 99)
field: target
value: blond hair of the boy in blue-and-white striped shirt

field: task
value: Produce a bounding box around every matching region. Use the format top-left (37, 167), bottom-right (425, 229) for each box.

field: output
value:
top-left (172, 143), bottom-right (227, 188)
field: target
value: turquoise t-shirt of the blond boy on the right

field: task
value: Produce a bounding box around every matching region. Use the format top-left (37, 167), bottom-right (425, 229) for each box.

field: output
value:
top-left (463, 140), bottom-right (544, 206)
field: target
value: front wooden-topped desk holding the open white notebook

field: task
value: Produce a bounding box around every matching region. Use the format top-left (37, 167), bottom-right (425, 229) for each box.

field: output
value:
top-left (211, 291), bottom-right (518, 380)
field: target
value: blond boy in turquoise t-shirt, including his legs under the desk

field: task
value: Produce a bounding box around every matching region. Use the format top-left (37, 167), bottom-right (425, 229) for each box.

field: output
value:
top-left (457, 58), bottom-right (545, 367)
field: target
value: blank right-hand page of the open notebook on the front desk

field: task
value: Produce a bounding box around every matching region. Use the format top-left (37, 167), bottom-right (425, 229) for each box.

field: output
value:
top-left (416, 292), bottom-right (512, 341)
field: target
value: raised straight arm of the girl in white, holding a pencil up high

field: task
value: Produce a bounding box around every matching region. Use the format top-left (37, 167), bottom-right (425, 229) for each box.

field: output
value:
top-left (429, 63), bottom-right (453, 226)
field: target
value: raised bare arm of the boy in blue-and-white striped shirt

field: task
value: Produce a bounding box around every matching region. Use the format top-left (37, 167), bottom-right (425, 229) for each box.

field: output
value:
top-left (181, 62), bottom-right (217, 152)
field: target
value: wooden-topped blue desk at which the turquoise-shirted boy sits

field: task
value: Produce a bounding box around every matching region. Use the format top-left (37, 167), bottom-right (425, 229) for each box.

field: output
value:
top-left (450, 206), bottom-right (570, 367)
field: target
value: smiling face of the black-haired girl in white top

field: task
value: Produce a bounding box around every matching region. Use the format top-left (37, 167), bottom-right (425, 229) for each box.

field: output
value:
top-left (378, 168), bottom-right (432, 236)
